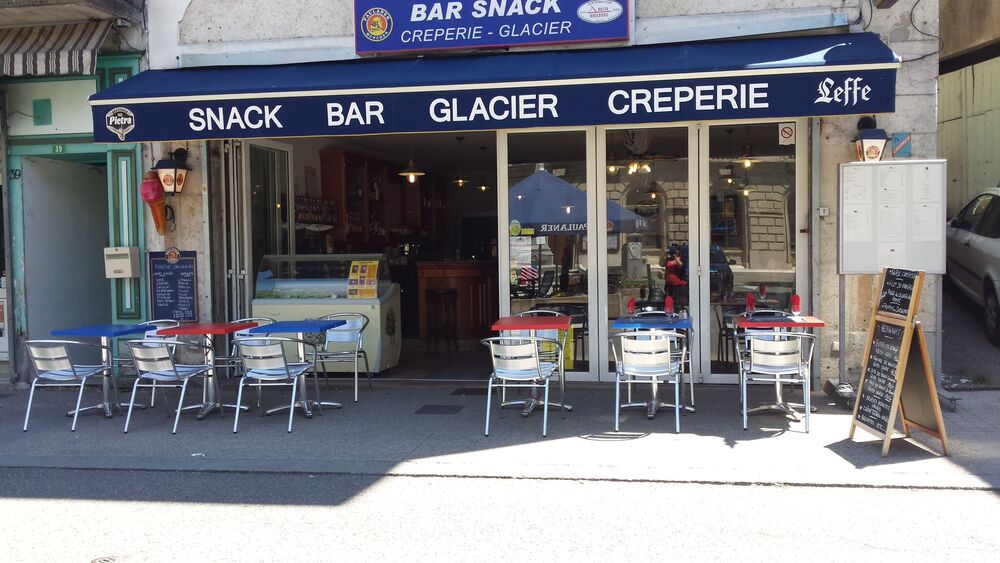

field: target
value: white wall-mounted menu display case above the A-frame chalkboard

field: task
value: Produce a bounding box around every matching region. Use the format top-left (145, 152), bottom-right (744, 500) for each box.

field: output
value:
top-left (839, 160), bottom-right (947, 274)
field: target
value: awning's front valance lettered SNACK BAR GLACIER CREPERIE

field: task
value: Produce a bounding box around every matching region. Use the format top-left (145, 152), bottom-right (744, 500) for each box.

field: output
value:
top-left (93, 69), bottom-right (896, 142)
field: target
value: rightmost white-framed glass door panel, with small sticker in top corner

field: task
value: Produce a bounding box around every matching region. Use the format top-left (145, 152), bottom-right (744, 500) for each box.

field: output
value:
top-left (699, 120), bottom-right (809, 383)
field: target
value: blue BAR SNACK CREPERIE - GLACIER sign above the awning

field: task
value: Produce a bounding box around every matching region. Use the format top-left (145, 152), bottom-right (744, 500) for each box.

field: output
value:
top-left (354, 0), bottom-right (629, 54)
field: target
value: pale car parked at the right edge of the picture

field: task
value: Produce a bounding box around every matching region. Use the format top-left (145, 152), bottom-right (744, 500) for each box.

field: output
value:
top-left (947, 187), bottom-right (1000, 342)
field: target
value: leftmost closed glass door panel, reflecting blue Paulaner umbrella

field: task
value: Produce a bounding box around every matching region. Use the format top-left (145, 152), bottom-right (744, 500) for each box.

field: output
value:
top-left (498, 131), bottom-right (596, 379)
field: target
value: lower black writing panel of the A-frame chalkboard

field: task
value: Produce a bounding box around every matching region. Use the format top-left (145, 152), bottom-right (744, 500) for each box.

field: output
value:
top-left (855, 321), bottom-right (905, 434)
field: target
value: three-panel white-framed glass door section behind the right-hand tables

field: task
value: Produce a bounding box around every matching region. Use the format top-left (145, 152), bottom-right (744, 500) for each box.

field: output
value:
top-left (498, 120), bottom-right (810, 383)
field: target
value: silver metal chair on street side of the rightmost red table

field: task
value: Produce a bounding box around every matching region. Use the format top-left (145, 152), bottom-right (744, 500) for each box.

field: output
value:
top-left (737, 330), bottom-right (816, 432)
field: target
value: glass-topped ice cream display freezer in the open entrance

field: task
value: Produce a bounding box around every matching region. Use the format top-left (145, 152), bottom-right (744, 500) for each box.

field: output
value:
top-left (251, 254), bottom-right (402, 373)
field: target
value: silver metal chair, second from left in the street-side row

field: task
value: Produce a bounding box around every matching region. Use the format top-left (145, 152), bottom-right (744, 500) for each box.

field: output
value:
top-left (124, 339), bottom-right (212, 434)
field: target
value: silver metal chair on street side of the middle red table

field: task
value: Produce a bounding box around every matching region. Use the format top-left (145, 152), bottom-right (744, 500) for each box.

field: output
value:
top-left (481, 336), bottom-right (562, 437)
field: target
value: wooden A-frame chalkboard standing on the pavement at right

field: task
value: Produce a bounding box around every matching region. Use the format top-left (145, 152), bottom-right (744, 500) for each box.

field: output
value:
top-left (850, 269), bottom-right (948, 457)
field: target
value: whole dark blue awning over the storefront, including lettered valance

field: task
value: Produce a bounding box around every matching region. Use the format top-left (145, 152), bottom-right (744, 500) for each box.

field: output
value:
top-left (90, 33), bottom-right (899, 142)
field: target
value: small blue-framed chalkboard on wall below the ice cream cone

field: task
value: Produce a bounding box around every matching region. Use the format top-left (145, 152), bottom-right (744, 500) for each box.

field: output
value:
top-left (149, 248), bottom-right (198, 321)
